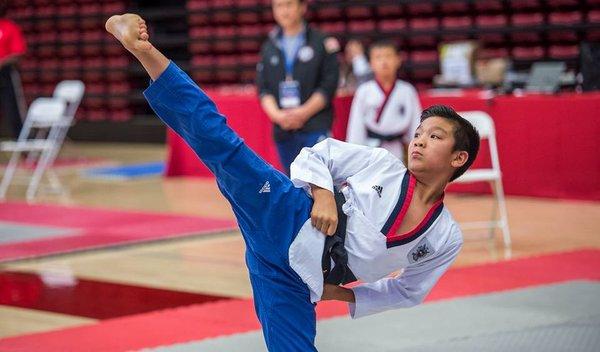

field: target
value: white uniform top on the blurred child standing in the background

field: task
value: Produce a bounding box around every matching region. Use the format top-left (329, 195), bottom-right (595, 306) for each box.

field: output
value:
top-left (346, 80), bottom-right (421, 159)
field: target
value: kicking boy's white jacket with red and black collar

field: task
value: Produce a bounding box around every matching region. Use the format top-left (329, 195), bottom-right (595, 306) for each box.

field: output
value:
top-left (289, 138), bottom-right (462, 318)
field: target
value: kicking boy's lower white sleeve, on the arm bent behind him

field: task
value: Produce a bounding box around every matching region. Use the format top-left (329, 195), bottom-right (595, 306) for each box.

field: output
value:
top-left (349, 241), bottom-right (462, 319)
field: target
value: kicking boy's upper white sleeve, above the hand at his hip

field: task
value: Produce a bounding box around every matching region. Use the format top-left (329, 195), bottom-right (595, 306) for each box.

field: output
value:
top-left (290, 138), bottom-right (387, 193)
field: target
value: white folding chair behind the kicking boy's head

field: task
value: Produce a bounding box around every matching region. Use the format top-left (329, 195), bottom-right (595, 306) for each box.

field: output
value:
top-left (454, 111), bottom-right (511, 249)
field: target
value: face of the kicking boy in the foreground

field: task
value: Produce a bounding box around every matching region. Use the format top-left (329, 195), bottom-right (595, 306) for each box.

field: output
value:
top-left (408, 116), bottom-right (468, 178)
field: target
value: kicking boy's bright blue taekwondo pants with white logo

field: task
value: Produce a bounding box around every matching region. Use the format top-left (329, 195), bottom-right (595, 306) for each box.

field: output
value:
top-left (144, 63), bottom-right (316, 352)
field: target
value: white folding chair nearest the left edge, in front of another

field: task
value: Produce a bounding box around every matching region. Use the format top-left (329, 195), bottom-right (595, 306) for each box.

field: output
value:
top-left (0, 98), bottom-right (70, 200)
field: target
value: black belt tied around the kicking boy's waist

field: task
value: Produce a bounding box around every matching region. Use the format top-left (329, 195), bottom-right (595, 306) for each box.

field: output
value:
top-left (321, 191), bottom-right (356, 285)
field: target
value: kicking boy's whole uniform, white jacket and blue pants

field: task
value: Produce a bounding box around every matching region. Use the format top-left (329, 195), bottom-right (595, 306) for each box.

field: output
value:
top-left (144, 63), bottom-right (462, 351)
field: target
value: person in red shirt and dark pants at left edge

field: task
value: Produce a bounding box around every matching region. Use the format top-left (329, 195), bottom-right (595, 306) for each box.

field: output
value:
top-left (0, 0), bottom-right (26, 137)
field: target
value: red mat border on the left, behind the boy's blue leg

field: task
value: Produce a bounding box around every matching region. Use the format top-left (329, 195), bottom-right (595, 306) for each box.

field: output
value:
top-left (0, 202), bottom-right (237, 262)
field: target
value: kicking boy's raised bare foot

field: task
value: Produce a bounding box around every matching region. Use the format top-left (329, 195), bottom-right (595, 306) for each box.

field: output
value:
top-left (105, 13), bottom-right (152, 51)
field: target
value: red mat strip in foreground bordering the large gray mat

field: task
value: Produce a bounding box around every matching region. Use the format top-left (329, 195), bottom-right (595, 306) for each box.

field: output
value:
top-left (0, 250), bottom-right (600, 352)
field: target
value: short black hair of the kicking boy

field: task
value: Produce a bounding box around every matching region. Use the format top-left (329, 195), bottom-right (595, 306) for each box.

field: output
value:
top-left (421, 105), bottom-right (479, 181)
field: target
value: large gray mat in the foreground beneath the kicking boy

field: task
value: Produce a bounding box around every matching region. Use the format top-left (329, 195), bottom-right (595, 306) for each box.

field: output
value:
top-left (147, 281), bottom-right (600, 352)
